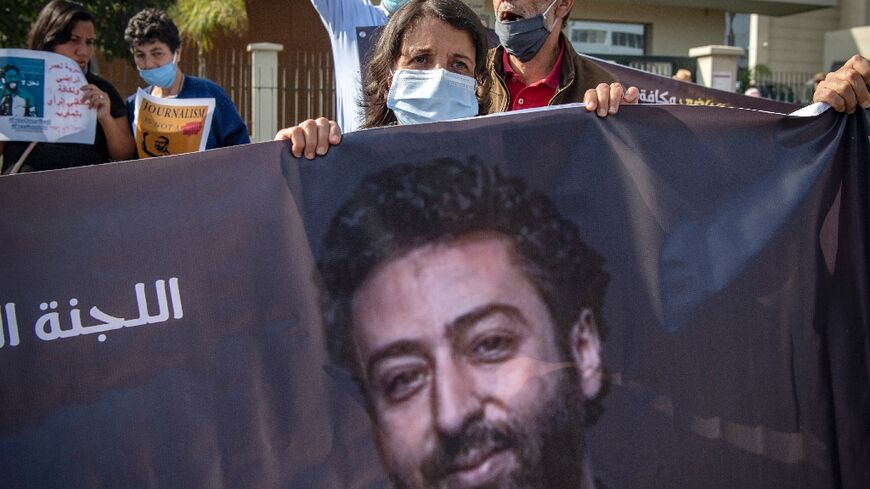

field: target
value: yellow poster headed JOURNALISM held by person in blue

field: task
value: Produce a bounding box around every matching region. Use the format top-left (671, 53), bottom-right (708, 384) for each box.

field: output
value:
top-left (134, 89), bottom-right (215, 158)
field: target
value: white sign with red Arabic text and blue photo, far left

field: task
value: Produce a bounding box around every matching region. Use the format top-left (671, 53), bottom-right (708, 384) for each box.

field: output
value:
top-left (0, 49), bottom-right (97, 144)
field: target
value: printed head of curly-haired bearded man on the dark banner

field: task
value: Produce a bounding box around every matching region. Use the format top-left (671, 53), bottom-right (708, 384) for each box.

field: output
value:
top-left (318, 160), bottom-right (608, 489)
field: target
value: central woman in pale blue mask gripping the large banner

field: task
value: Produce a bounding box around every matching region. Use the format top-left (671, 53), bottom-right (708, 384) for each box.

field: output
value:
top-left (275, 0), bottom-right (488, 159)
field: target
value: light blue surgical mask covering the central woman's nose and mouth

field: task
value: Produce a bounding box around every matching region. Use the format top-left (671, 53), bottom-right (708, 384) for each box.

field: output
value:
top-left (387, 69), bottom-right (477, 124)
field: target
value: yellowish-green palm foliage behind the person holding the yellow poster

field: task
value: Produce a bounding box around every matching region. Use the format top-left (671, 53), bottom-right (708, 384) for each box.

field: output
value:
top-left (169, 0), bottom-right (248, 77)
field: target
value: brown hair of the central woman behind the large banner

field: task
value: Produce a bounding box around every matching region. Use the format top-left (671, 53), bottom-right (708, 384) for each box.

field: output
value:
top-left (360, 0), bottom-right (489, 128)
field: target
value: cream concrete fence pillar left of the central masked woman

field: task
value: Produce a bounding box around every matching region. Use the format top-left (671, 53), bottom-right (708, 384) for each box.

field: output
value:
top-left (248, 42), bottom-right (284, 143)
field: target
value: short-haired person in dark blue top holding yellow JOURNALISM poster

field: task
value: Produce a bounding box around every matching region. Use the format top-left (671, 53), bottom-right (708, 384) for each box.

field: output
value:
top-left (124, 8), bottom-right (251, 158)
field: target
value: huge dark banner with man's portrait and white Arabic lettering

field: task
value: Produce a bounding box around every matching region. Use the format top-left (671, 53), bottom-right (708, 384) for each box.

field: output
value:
top-left (0, 105), bottom-right (870, 489)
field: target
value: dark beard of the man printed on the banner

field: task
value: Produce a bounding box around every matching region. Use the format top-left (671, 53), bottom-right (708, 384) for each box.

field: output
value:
top-left (389, 369), bottom-right (585, 489)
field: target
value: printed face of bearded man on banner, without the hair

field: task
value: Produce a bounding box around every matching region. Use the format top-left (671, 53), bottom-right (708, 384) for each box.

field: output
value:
top-left (353, 234), bottom-right (597, 488)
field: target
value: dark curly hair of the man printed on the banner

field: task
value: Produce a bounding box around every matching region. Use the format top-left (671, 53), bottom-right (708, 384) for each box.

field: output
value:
top-left (317, 159), bottom-right (609, 386)
